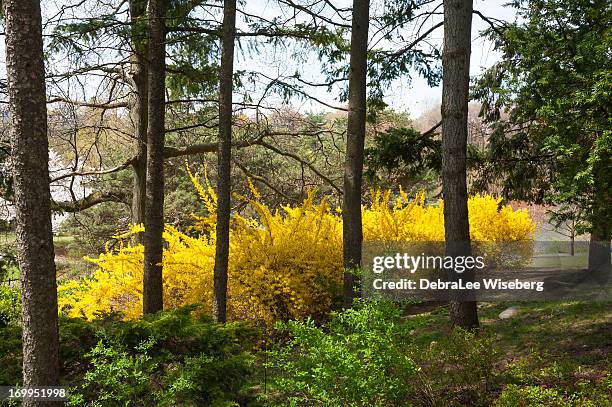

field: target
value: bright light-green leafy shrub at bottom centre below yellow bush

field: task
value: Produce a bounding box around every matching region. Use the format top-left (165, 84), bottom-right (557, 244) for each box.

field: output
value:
top-left (270, 302), bottom-right (417, 406)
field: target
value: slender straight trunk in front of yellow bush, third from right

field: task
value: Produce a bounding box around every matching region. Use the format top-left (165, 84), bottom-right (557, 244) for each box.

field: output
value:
top-left (213, 0), bottom-right (236, 322)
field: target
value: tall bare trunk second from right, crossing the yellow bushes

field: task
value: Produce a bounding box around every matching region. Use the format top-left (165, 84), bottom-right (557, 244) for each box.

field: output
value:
top-left (342, 0), bottom-right (370, 307)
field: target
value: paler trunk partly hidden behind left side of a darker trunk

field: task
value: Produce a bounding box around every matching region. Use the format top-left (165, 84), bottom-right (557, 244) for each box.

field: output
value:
top-left (129, 0), bottom-right (149, 236)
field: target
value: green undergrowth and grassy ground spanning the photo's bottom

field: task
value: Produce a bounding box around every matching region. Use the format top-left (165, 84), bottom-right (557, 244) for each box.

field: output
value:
top-left (0, 287), bottom-right (612, 407)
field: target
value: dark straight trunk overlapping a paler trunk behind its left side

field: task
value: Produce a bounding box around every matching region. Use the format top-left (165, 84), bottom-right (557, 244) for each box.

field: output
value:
top-left (143, 0), bottom-right (166, 314)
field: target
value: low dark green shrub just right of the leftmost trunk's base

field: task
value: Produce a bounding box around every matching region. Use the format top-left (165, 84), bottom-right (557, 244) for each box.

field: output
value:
top-left (68, 308), bottom-right (256, 405)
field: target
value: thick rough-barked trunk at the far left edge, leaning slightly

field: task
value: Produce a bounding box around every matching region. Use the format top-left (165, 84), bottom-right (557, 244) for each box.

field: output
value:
top-left (4, 0), bottom-right (59, 398)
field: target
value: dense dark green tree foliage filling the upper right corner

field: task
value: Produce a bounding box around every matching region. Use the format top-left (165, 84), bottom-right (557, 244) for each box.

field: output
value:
top-left (475, 0), bottom-right (612, 236)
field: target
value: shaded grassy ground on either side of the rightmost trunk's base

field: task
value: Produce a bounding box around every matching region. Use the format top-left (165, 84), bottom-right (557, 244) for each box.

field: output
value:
top-left (405, 301), bottom-right (612, 368)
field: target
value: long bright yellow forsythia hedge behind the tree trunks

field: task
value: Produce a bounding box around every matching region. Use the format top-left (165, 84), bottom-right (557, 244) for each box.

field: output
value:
top-left (59, 175), bottom-right (534, 322)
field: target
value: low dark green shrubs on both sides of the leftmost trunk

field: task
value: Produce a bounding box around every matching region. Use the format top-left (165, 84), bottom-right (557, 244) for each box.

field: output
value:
top-left (0, 307), bottom-right (258, 406)
